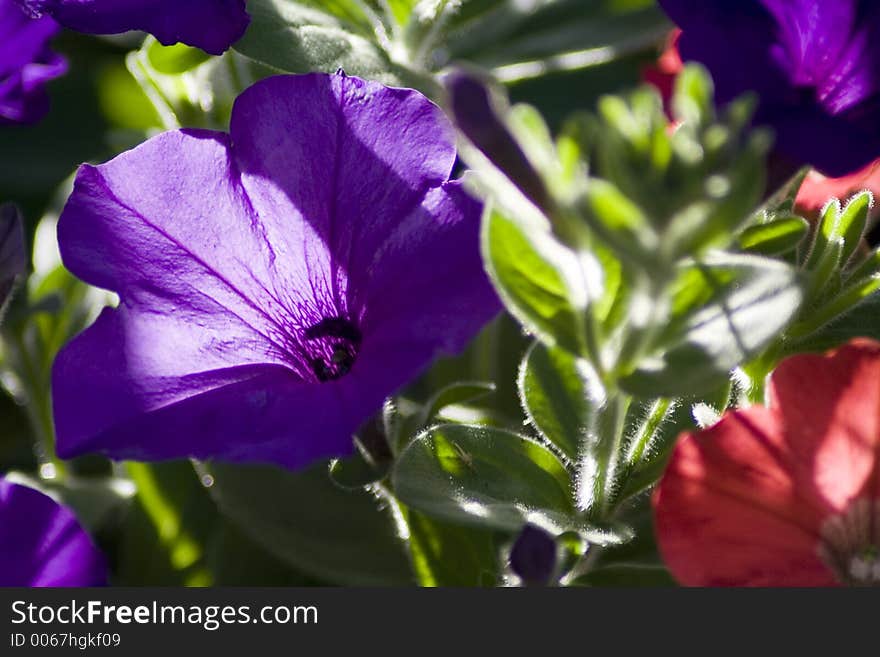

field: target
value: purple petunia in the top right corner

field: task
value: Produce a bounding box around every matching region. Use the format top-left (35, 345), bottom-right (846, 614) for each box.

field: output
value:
top-left (660, 0), bottom-right (880, 177)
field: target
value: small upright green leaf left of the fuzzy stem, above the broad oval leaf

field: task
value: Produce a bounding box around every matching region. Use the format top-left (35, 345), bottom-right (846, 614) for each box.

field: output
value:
top-left (519, 342), bottom-right (605, 461)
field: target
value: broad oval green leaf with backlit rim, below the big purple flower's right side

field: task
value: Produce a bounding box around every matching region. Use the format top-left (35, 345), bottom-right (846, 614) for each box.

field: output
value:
top-left (391, 424), bottom-right (622, 543)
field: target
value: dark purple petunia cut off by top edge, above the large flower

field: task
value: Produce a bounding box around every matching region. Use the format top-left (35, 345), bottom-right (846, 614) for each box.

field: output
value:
top-left (16, 0), bottom-right (250, 55)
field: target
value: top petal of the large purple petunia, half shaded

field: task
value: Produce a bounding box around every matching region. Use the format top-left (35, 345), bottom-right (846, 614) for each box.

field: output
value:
top-left (231, 74), bottom-right (455, 296)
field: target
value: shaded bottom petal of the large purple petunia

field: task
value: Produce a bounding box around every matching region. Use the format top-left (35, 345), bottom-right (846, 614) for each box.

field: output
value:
top-left (53, 308), bottom-right (381, 468)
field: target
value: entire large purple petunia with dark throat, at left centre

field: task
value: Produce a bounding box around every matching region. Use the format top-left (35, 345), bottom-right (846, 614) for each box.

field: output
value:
top-left (53, 74), bottom-right (499, 468)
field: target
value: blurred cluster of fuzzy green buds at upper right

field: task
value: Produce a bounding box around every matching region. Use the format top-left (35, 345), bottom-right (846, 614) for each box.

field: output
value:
top-left (577, 65), bottom-right (769, 264)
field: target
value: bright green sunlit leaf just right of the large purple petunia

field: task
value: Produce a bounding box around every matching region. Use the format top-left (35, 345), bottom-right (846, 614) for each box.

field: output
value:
top-left (482, 205), bottom-right (587, 354)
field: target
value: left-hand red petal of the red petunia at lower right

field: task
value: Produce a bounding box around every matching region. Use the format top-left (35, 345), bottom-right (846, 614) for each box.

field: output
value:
top-left (654, 407), bottom-right (834, 586)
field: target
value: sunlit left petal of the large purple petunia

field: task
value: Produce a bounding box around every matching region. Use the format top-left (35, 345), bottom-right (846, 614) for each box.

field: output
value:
top-left (58, 131), bottom-right (308, 376)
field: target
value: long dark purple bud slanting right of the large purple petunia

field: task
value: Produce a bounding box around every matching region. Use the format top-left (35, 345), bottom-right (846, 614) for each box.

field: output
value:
top-left (445, 69), bottom-right (547, 207)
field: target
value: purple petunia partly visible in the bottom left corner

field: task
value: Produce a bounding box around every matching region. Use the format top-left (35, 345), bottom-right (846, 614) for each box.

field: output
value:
top-left (0, 477), bottom-right (107, 586)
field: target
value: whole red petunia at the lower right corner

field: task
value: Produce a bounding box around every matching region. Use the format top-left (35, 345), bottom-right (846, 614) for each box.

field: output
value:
top-left (654, 339), bottom-right (880, 586)
